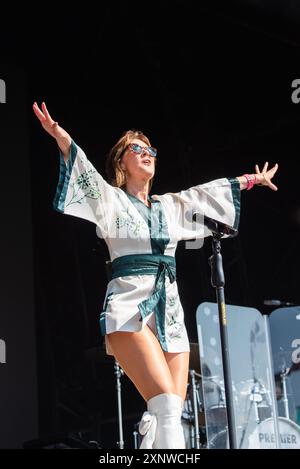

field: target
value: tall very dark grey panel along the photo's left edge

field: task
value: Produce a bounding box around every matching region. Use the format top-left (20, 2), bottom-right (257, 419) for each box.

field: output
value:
top-left (0, 64), bottom-right (38, 449)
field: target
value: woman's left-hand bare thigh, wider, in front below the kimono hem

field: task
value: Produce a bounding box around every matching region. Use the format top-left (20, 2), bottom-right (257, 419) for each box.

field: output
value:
top-left (106, 325), bottom-right (177, 401)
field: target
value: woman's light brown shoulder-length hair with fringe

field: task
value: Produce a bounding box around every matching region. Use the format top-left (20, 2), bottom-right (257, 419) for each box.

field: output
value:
top-left (106, 129), bottom-right (156, 191)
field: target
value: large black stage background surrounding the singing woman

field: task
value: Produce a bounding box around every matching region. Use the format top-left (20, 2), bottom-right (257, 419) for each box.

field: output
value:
top-left (0, 0), bottom-right (300, 448)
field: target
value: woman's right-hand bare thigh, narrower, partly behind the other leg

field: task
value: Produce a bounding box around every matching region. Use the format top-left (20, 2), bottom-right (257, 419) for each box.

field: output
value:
top-left (163, 352), bottom-right (190, 400)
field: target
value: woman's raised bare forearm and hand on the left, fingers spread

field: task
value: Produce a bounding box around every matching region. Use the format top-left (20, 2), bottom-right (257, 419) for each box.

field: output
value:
top-left (33, 102), bottom-right (72, 163)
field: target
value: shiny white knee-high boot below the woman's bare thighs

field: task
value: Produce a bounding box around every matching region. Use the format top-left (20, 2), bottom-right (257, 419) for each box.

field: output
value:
top-left (139, 393), bottom-right (185, 449)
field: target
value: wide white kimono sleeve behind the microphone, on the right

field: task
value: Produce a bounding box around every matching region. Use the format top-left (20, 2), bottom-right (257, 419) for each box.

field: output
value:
top-left (162, 178), bottom-right (240, 240)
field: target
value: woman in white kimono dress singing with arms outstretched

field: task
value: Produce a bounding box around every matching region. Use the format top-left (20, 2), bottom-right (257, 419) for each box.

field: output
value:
top-left (33, 103), bottom-right (278, 449)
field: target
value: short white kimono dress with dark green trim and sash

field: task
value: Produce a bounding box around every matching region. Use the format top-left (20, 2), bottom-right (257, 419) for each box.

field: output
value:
top-left (53, 141), bottom-right (240, 355)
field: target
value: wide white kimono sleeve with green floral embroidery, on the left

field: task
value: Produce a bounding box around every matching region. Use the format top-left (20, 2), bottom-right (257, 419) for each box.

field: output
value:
top-left (53, 141), bottom-right (115, 236)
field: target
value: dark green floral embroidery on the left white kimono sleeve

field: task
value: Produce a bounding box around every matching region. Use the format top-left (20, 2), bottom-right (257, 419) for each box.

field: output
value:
top-left (66, 169), bottom-right (101, 207)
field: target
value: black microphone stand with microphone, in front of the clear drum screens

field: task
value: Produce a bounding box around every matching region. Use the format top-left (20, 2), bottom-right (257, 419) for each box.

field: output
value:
top-left (204, 216), bottom-right (238, 449)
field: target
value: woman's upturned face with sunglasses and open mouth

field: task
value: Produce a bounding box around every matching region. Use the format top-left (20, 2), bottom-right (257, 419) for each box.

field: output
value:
top-left (120, 138), bottom-right (156, 180)
